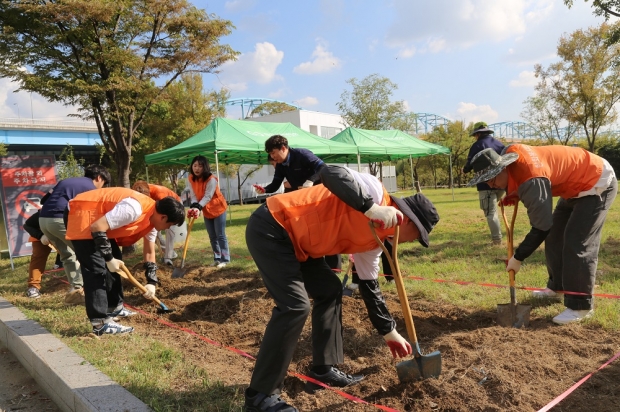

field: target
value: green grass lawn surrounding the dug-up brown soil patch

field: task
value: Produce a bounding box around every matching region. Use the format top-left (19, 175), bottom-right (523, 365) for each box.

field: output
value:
top-left (0, 188), bottom-right (620, 411)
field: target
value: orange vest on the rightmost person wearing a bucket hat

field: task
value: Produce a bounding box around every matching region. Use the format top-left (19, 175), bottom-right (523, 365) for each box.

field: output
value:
top-left (506, 144), bottom-right (603, 199)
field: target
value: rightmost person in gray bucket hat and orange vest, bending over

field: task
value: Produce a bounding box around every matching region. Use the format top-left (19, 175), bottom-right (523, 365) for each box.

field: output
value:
top-left (467, 144), bottom-right (618, 325)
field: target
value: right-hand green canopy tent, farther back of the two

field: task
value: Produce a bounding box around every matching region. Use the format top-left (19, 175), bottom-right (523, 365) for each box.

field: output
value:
top-left (325, 127), bottom-right (454, 196)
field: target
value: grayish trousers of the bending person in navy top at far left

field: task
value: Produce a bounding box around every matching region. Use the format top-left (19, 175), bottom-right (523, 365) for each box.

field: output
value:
top-left (39, 217), bottom-right (84, 289)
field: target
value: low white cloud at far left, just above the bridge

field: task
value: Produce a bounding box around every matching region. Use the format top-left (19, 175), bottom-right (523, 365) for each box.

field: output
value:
top-left (0, 79), bottom-right (78, 120)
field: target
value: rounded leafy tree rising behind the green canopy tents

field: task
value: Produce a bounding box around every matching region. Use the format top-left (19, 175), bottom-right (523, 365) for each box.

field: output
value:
top-left (336, 74), bottom-right (411, 175)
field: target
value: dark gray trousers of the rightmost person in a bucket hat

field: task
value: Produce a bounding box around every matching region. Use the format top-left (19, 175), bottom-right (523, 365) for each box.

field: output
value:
top-left (545, 178), bottom-right (618, 310)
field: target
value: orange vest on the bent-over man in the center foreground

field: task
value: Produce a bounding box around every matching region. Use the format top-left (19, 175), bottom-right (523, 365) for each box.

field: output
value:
top-left (267, 184), bottom-right (396, 262)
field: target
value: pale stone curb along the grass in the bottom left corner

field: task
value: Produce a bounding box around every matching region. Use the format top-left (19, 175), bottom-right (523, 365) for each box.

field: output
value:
top-left (0, 297), bottom-right (152, 412)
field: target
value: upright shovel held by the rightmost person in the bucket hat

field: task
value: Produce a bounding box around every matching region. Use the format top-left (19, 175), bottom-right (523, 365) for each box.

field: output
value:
top-left (497, 202), bottom-right (532, 328)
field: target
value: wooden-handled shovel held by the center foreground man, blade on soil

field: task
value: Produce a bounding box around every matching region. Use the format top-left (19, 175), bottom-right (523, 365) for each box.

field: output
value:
top-left (370, 222), bottom-right (441, 383)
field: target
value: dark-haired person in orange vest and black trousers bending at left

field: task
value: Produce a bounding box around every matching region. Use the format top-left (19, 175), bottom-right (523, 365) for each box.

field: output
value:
top-left (65, 187), bottom-right (185, 336)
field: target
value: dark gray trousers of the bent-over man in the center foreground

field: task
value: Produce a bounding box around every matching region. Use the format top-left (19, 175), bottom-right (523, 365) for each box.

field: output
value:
top-left (245, 205), bottom-right (344, 394)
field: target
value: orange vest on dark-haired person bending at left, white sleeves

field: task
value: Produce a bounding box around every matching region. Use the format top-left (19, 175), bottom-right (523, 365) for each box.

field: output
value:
top-left (65, 187), bottom-right (155, 246)
